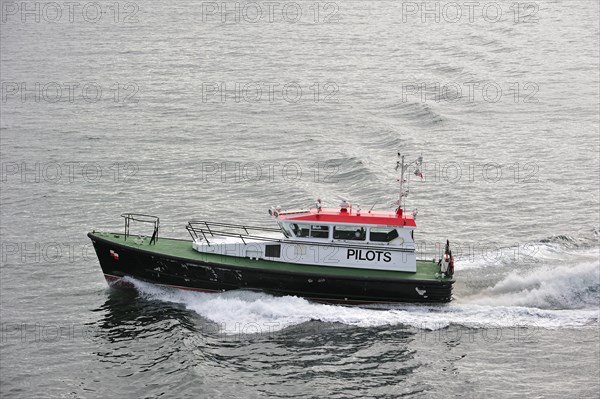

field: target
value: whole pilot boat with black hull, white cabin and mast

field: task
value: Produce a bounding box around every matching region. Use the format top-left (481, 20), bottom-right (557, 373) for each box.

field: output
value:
top-left (88, 154), bottom-right (454, 304)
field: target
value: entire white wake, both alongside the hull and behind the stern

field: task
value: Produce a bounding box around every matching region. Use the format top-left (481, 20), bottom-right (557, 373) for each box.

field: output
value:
top-left (120, 230), bottom-right (600, 334)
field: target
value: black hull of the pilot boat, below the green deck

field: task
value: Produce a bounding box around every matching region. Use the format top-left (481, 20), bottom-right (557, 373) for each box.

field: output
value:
top-left (88, 233), bottom-right (453, 304)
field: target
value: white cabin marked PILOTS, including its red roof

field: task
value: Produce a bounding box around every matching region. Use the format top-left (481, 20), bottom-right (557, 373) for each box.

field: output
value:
top-left (193, 207), bottom-right (417, 272)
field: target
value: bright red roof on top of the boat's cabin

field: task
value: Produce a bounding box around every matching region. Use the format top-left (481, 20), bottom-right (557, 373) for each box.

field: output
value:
top-left (277, 208), bottom-right (417, 227)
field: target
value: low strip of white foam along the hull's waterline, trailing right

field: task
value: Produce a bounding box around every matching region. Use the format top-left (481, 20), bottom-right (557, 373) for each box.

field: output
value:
top-left (124, 279), bottom-right (599, 334)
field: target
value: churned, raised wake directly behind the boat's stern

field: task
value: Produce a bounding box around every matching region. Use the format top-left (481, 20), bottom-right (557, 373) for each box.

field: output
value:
top-left (455, 235), bottom-right (600, 310)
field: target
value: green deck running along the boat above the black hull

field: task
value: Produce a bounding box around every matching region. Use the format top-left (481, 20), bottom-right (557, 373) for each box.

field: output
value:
top-left (90, 232), bottom-right (453, 282)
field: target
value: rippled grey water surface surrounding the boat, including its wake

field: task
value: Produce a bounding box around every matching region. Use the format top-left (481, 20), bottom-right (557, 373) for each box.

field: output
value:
top-left (0, 0), bottom-right (600, 398)
